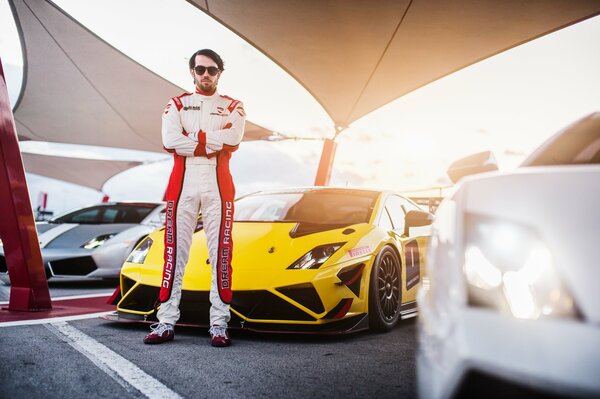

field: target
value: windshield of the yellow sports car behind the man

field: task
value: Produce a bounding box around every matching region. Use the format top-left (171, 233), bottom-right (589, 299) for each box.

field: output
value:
top-left (235, 189), bottom-right (379, 225)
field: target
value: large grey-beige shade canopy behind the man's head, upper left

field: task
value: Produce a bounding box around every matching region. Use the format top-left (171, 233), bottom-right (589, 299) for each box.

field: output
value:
top-left (10, 0), bottom-right (271, 152)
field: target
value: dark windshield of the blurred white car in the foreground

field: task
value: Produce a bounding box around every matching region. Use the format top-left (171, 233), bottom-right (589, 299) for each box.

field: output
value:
top-left (523, 115), bottom-right (600, 166)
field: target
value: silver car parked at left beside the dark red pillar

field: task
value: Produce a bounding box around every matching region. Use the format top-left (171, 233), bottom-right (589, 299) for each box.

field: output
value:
top-left (0, 202), bottom-right (165, 283)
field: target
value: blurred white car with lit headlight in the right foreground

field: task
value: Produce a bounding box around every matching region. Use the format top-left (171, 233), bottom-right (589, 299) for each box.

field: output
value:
top-left (417, 113), bottom-right (600, 398)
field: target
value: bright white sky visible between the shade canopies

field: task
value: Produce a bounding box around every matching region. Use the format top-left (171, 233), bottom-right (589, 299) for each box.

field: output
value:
top-left (0, 0), bottom-right (600, 216)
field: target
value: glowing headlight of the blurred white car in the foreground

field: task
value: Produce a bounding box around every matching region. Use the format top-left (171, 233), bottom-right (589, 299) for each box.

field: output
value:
top-left (463, 215), bottom-right (577, 319)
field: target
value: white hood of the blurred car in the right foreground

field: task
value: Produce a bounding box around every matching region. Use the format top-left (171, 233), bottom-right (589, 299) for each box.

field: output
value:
top-left (454, 165), bottom-right (600, 324)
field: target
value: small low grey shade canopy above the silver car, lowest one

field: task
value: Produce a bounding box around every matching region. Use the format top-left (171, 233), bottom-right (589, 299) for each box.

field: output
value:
top-left (21, 152), bottom-right (142, 191)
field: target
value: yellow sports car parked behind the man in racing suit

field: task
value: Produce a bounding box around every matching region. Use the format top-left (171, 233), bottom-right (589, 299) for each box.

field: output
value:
top-left (106, 187), bottom-right (433, 333)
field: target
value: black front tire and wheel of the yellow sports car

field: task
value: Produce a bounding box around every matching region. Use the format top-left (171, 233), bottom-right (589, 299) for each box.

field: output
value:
top-left (369, 246), bottom-right (402, 332)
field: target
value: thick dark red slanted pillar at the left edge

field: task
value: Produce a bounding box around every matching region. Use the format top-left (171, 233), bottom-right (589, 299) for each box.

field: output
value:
top-left (0, 59), bottom-right (52, 311)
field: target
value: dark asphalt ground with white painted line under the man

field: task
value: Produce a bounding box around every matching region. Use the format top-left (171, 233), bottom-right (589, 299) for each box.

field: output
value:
top-left (0, 282), bottom-right (416, 398)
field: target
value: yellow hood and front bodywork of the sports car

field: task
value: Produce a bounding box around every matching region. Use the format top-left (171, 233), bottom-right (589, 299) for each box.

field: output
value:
top-left (133, 222), bottom-right (381, 290)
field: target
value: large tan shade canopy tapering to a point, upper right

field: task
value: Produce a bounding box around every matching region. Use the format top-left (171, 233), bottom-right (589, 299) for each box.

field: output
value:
top-left (188, 0), bottom-right (600, 127)
